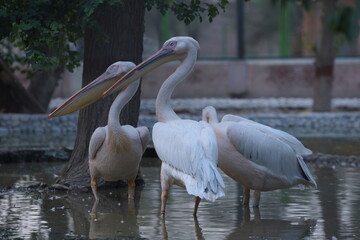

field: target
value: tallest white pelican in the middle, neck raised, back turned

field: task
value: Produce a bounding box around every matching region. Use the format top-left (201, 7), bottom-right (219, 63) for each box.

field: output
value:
top-left (104, 37), bottom-right (225, 216)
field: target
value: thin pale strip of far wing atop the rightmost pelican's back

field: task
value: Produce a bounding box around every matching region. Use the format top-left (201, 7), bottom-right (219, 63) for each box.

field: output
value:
top-left (221, 114), bottom-right (312, 155)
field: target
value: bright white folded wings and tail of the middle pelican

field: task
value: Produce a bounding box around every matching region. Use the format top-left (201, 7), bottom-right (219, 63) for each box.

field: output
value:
top-left (152, 120), bottom-right (224, 200)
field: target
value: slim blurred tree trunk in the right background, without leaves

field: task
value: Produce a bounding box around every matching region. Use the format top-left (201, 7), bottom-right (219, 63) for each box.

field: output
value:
top-left (312, 0), bottom-right (337, 112)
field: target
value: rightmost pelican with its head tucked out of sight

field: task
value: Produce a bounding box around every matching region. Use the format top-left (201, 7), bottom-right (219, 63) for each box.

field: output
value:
top-left (202, 106), bottom-right (316, 207)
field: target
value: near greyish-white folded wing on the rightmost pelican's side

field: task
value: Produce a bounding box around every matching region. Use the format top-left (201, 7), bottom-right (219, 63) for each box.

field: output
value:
top-left (226, 122), bottom-right (311, 183)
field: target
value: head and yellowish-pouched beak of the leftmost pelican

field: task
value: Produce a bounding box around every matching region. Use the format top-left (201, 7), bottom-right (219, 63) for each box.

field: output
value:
top-left (48, 61), bottom-right (135, 119)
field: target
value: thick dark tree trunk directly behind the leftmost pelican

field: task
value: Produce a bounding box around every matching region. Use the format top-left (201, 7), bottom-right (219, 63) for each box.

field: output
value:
top-left (57, 0), bottom-right (145, 187)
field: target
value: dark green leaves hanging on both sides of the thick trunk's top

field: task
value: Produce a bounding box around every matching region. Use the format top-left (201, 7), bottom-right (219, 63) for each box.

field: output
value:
top-left (0, 0), bottom-right (228, 77)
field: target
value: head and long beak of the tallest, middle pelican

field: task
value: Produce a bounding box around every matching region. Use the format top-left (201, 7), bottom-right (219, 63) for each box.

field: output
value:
top-left (103, 36), bottom-right (200, 97)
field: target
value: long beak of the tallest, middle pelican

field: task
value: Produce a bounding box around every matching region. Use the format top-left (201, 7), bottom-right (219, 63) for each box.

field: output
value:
top-left (102, 48), bottom-right (179, 97)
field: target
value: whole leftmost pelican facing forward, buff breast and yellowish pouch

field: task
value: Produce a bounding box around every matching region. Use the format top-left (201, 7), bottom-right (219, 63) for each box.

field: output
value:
top-left (49, 62), bottom-right (149, 202)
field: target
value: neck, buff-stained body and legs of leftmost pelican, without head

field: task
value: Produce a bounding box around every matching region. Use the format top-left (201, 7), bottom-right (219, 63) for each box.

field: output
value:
top-left (89, 76), bottom-right (149, 199)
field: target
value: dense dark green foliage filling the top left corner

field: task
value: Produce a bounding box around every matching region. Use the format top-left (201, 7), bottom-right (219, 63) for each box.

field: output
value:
top-left (0, 0), bottom-right (105, 75)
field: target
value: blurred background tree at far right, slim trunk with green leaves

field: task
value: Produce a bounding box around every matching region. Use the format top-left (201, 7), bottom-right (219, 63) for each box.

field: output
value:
top-left (272, 0), bottom-right (360, 112)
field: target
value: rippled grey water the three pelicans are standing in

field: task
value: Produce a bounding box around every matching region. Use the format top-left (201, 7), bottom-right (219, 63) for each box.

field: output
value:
top-left (0, 159), bottom-right (360, 239)
